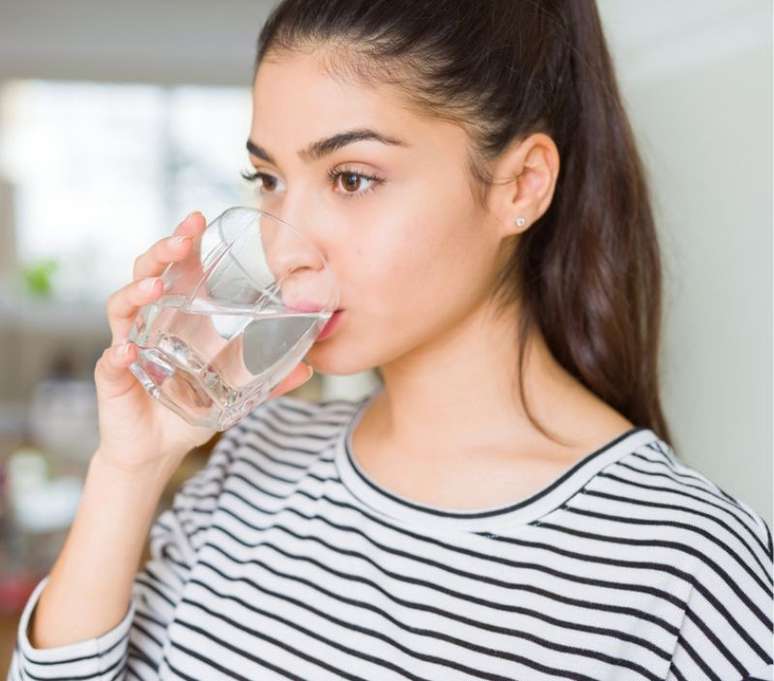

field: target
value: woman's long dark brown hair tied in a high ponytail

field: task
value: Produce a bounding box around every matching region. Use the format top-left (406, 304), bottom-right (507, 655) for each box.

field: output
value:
top-left (255, 0), bottom-right (671, 443)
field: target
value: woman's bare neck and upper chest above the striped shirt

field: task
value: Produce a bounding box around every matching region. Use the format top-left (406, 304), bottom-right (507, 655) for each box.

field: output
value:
top-left (352, 300), bottom-right (633, 508)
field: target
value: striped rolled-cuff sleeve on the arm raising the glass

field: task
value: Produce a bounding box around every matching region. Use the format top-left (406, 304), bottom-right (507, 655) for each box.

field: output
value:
top-left (7, 437), bottom-right (234, 681)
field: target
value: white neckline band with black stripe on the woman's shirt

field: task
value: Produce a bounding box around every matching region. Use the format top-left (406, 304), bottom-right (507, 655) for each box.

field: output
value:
top-left (334, 387), bottom-right (658, 533)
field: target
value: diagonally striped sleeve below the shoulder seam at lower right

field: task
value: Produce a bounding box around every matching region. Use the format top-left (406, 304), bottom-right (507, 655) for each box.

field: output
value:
top-left (666, 504), bottom-right (774, 681)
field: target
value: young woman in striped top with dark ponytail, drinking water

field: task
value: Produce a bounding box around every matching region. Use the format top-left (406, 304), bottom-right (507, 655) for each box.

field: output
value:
top-left (10, 0), bottom-right (772, 681)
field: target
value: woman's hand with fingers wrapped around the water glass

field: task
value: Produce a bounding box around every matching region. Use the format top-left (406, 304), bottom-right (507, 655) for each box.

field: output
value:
top-left (94, 212), bottom-right (312, 475)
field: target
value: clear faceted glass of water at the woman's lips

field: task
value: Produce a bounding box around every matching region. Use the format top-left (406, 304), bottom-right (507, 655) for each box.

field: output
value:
top-left (129, 206), bottom-right (339, 431)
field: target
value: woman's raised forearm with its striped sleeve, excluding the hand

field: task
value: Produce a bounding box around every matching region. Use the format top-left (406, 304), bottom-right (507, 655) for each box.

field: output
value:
top-left (8, 434), bottom-right (239, 681)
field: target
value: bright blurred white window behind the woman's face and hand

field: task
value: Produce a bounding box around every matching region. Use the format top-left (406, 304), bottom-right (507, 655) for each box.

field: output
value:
top-left (0, 80), bottom-right (253, 302)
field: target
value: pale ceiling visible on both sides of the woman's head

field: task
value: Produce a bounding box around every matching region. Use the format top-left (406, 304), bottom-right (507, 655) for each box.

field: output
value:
top-left (0, 0), bottom-right (772, 85)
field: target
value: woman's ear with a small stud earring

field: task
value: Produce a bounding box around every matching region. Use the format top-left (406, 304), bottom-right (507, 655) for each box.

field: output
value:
top-left (489, 132), bottom-right (559, 237)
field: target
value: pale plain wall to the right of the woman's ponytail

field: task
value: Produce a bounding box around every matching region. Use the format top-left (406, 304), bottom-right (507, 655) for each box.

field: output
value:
top-left (599, 0), bottom-right (773, 522)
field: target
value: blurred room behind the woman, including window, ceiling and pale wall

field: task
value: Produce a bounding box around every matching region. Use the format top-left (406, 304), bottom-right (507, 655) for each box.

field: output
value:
top-left (0, 0), bottom-right (772, 671)
